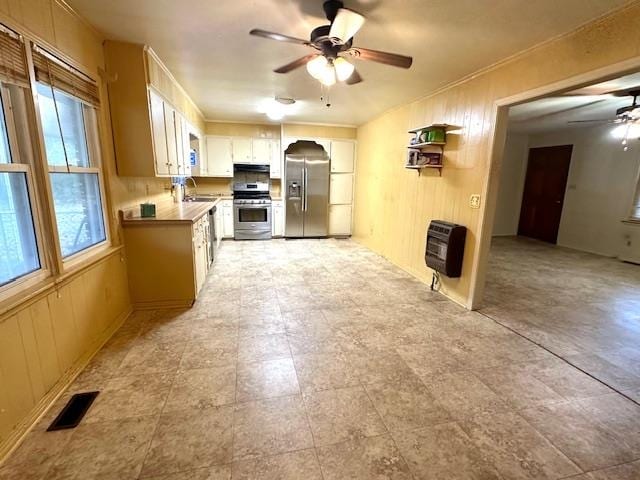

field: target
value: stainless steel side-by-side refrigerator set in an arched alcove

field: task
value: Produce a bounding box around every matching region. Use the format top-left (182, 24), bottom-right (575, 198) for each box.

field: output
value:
top-left (284, 140), bottom-right (329, 238)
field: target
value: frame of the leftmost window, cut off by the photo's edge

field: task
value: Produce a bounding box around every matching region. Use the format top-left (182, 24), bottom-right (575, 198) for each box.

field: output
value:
top-left (0, 81), bottom-right (51, 301)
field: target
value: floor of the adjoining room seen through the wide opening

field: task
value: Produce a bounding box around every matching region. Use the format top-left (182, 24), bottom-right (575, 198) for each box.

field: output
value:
top-left (481, 237), bottom-right (640, 402)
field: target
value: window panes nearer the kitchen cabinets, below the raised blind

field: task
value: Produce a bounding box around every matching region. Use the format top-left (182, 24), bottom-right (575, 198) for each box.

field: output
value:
top-left (37, 83), bottom-right (107, 258)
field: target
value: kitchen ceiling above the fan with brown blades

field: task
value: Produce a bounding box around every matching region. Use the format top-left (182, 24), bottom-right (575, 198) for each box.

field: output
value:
top-left (69, 0), bottom-right (629, 125)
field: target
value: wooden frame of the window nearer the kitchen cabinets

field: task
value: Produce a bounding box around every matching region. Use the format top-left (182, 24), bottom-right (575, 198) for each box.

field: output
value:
top-left (32, 79), bottom-right (112, 266)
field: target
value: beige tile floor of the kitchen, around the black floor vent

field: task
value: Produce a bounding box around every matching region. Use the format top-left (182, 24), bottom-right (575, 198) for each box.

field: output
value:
top-left (0, 240), bottom-right (640, 480)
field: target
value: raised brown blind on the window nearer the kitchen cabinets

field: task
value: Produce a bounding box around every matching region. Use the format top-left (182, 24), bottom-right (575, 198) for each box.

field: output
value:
top-left (33, 46), bottom-right (100, 107)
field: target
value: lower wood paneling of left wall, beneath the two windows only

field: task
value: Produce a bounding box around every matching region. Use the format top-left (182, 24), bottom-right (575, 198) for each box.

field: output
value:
top-left (0, 249), bottom-right (131, 459)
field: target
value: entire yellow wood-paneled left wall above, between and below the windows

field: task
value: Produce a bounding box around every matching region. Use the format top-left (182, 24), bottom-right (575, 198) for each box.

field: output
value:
top-left (0, 0), bottom-right (135, 460)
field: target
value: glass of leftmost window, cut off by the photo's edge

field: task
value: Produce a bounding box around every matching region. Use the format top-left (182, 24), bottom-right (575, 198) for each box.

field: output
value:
top-left (0, 90), bottom-right (40, 286)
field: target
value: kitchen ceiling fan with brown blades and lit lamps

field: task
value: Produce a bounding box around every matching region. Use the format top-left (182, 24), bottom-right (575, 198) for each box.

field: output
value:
top-left (249, 0), bottom-right (413, 86)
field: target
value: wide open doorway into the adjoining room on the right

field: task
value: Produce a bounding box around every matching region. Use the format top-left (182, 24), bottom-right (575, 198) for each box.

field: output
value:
top-left (479, 69), bottom-right (640, 404)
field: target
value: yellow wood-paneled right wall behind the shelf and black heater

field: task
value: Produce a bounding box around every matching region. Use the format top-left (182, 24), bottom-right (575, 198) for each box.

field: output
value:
top-left (354, 2), bottom-right (640, 306)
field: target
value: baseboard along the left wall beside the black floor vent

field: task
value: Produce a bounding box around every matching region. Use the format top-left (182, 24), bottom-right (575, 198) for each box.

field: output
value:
top-left (0, 307), bottom-right (133, 465)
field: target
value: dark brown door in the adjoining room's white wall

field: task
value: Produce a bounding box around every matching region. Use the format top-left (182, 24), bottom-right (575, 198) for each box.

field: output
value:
top-left (518, 145), bottom-right (573, 244)
